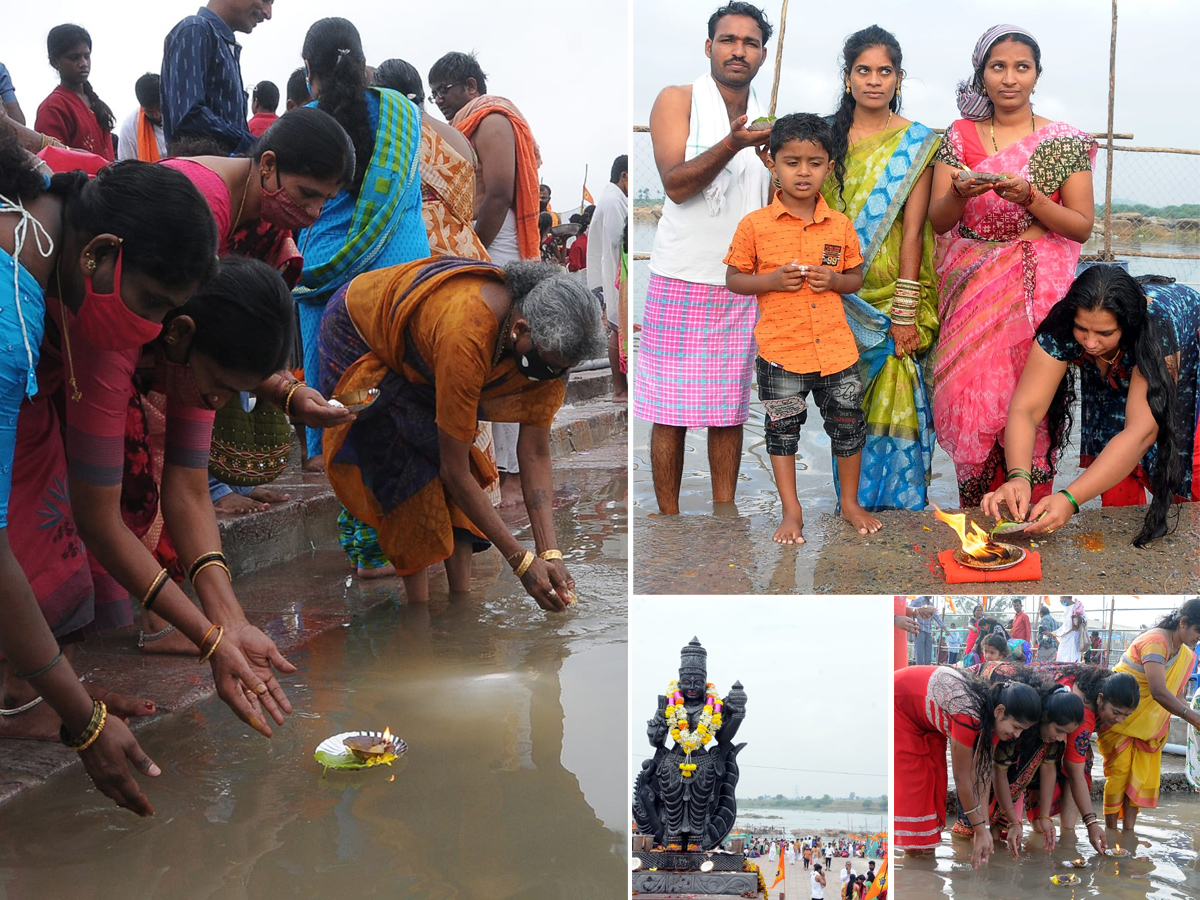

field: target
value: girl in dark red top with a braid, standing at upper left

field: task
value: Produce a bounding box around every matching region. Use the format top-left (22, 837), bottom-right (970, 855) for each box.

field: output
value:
top-left (34, 25), bottom-right (115, 162)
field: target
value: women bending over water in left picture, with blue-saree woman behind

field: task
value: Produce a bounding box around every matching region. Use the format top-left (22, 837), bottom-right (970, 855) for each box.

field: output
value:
top-left (0, 19), bottom-right (604, 815)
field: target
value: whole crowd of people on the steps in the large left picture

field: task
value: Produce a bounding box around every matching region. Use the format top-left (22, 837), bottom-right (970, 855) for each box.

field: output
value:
top-left (0, 0), bottom-right (628, 815)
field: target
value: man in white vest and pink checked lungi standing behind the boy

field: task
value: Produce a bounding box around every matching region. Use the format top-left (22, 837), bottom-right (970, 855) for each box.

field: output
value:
top-left (634, 2), bottom-right (772, 515)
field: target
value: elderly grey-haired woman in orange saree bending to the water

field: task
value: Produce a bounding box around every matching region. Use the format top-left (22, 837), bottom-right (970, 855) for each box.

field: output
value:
top-left (318, 257), bottom-right (606, 611)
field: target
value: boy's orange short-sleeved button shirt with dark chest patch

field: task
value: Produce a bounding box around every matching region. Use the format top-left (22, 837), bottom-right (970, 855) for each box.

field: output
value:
top-left (725, 191), bottom-right (863, 376)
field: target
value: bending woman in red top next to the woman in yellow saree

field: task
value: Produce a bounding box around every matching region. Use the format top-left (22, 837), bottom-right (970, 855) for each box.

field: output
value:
top-left (1027, 665), bottom-right (1140, 852)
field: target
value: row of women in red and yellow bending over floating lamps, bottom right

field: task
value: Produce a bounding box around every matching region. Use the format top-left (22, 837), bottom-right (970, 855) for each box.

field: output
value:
top-left (895, 599), bottom-right (1200, 868)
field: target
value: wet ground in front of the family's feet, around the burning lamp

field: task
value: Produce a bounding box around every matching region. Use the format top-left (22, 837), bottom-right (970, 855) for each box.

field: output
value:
top-left (634, 503), bottom-right (1200, 594)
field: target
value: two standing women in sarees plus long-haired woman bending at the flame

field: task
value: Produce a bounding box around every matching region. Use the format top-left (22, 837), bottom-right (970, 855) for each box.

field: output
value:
top-left (822, 25), bottom-right (1200, 546)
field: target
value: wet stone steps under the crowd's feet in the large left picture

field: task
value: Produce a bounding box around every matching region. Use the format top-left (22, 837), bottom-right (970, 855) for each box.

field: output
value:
top-left (0, 386), bottom-right (628, 811)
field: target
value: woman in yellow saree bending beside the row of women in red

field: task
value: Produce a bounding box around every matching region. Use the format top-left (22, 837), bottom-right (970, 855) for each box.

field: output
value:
top-left (1098, 599), bottom-right (1200, 832)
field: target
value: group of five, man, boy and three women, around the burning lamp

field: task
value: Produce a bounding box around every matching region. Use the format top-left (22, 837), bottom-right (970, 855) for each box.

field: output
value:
top-left (634, 1), bottom-right (1200, 546)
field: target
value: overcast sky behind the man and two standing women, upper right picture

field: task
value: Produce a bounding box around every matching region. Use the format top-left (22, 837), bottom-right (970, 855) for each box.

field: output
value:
top-left (631, 0), bottom-right (1200, 204)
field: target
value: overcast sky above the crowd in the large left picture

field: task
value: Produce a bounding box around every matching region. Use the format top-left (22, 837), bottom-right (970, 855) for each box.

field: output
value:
top-left (0, 0), bottom-right (629, 210)
